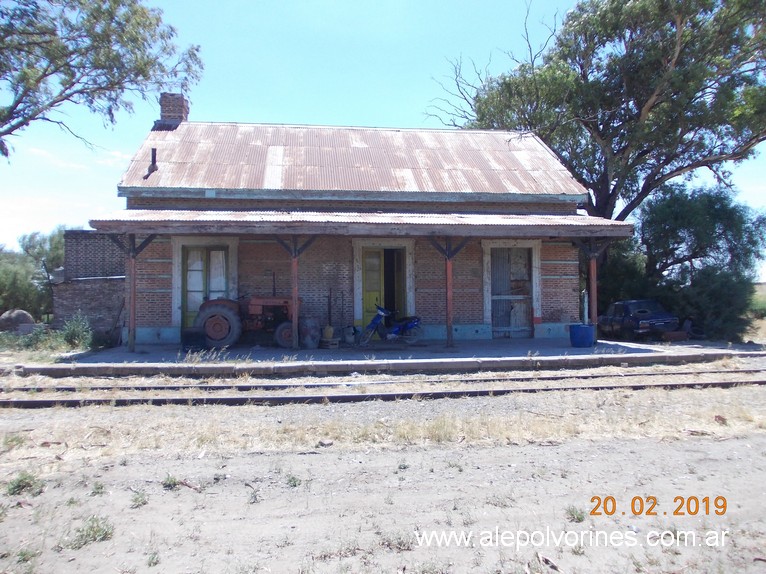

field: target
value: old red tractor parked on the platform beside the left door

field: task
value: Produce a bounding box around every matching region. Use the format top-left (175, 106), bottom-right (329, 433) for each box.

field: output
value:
top-left (194, 297), bottom-right (293, 348)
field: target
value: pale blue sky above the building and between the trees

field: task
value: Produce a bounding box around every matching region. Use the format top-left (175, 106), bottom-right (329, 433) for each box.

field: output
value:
top-left (0, 0), bottom-right (766, 280)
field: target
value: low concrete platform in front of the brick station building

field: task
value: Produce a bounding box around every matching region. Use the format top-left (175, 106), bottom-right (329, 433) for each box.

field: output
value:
top-left (14, 339), bottom-right (766, 377)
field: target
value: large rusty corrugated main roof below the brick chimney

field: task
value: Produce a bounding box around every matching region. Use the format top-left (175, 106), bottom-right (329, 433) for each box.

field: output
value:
top-left (119, 122), bottom-right (585, 197)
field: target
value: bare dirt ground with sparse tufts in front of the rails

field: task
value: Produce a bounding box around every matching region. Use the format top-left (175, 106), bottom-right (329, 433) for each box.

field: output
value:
top-left (0, 359), bottom-right (766, 574)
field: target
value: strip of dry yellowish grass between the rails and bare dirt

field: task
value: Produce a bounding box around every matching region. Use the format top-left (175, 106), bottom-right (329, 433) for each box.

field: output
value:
top-left (0, 386), bottom-right (766, 474)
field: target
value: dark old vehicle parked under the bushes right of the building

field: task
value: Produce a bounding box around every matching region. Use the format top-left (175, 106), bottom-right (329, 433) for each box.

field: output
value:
top-left (598, 299), bottom-right (678, 340)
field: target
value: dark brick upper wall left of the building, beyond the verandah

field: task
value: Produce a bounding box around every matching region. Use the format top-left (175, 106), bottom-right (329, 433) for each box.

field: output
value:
top-left (64, 230), bottom-right (125, 280)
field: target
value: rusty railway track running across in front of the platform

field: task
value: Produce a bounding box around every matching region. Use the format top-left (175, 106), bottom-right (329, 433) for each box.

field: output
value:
top-left (0, 369), bottom-right (766, 409)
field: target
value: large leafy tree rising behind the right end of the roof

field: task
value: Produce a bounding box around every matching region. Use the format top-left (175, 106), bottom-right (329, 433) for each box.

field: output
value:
top-left (448, 0), bottom-right (766, 220)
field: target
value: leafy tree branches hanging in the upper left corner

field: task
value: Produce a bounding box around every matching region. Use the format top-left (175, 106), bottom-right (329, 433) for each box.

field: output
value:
top-left (0, 0), bottom-right (202, 156)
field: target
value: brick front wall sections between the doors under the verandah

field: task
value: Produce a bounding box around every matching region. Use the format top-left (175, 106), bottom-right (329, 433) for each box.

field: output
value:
top-left (129, 236), bottom-right (580, 338)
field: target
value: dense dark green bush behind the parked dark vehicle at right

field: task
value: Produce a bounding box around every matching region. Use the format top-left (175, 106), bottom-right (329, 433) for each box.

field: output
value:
top-left (599, 186), bottom-right (766, 341)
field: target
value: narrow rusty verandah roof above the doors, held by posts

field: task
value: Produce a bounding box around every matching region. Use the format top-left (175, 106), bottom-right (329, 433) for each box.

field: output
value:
top-left (90, 209), bottom-right (633, 237)
